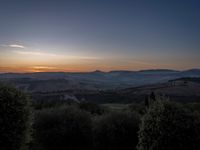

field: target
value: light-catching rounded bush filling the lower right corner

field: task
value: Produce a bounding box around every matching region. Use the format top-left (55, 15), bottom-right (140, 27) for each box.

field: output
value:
top-left (138, 101), bottom-right (200, 150)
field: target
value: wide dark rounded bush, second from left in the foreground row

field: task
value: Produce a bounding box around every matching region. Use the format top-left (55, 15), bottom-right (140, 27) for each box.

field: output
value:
top-left (34, 106), bottom-right (92, 150)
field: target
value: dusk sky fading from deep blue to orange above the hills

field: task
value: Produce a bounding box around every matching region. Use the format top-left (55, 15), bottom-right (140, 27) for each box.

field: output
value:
top-left (0, 0), bottom-right (200, 72)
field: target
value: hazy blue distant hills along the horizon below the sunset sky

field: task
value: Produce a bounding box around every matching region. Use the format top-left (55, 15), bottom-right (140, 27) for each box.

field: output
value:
top-left (0, 69), bottom-right (200, 92)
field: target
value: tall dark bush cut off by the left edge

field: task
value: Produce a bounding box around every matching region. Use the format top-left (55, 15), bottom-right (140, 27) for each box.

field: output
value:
top-left (0, 86), bottom-right (30, 150)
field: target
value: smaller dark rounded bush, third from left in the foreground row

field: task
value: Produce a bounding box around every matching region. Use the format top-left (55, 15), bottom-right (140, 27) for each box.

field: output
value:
top-left (93, 112), bottom-right (139, 150)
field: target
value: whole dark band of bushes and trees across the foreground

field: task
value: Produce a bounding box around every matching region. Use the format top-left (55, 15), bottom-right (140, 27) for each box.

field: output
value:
top-left (0, 86), bottom-right (200, 150)
